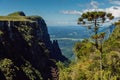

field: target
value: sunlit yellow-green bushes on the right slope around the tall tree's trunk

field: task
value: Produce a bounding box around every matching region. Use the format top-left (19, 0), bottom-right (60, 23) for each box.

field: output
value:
top-left (58, 23), bottom-right (120, 80)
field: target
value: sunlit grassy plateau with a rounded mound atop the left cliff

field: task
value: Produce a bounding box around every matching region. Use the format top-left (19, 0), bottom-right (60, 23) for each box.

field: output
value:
top-left (0, 11), bottom-right (42, 22)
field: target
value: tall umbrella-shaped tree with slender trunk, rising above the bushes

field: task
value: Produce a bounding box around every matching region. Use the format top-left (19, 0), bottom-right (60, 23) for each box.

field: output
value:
top-left (78, 11), bottom-right (114, 80)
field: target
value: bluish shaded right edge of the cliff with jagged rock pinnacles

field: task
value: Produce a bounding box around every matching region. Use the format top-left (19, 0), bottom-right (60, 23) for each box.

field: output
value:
top-left (37, 19), bottom-right (68, 62)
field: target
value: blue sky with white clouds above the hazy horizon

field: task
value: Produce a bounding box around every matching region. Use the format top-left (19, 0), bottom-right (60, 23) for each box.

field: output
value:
top-left (0, 0), bottom-right (120, 26)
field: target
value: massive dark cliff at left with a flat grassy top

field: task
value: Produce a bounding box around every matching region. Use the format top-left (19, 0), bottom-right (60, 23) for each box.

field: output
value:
top-left (0, 13), bottom-right (67, 80)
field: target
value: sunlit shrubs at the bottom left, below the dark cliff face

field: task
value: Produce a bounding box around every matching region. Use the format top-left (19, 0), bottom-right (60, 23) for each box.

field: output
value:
top-left (0, 58), bottom-right (43, 80)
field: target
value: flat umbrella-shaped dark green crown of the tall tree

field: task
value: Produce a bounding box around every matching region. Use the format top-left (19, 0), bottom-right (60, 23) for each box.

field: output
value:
top-left (78, 11), bottom-right (114, 24)
